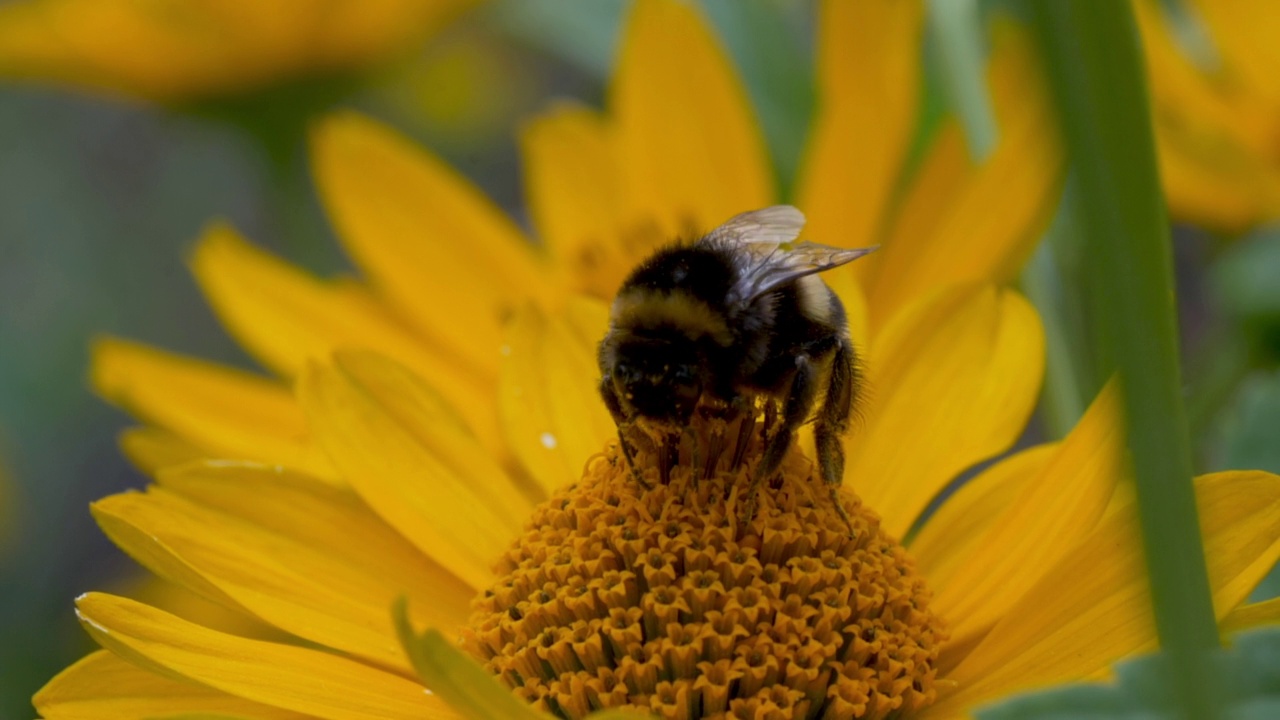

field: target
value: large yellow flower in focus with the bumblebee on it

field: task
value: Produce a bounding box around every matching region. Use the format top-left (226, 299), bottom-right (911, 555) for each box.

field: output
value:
top-left (36, 0), bottom-right (1280, 720)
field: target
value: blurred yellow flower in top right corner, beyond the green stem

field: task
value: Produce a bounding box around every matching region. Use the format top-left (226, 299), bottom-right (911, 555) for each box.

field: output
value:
top-left (1135, 0), bottom-right (1280, 233)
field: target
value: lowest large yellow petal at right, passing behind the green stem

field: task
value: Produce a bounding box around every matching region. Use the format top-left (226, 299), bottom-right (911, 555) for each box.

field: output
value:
top-left (924, 471), bottom-right (1280, 717)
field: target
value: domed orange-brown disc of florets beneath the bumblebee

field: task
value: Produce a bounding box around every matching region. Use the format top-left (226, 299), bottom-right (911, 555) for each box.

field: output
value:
top-left (463, 422), bottom-right (946, 717)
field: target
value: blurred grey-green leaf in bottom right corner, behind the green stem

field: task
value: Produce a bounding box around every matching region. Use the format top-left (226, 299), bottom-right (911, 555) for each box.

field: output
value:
top-left (977, 628), bottom-right (1280, 720)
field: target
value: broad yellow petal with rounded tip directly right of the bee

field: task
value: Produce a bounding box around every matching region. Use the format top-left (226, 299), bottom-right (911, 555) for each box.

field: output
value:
top-left (845, 287), bottom-right (1044, 537)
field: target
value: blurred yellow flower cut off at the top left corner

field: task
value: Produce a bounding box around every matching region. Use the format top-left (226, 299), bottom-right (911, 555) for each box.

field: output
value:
top-left (0, 0), bottom-right (474, 102)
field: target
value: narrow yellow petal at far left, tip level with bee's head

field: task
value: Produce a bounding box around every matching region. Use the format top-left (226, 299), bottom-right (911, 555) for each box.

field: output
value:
top-left (91, 338), bottom-right (334, 478)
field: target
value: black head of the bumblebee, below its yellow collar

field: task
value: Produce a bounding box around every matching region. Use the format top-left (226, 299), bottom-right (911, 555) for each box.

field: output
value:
top-left (612, 337), bottom-right (703, 424)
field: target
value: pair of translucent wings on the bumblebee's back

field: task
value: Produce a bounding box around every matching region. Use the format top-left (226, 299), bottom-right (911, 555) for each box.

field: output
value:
top-left (705, 205), bottom-right (876, 306)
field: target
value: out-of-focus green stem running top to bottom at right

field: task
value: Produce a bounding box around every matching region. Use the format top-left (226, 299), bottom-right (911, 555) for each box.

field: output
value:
top-left (1030, 0), bottom-right (1217, 719)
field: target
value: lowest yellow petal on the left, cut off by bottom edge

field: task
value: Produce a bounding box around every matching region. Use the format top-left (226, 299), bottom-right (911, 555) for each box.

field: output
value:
top-left (32, 650), bottom-right (307, 720)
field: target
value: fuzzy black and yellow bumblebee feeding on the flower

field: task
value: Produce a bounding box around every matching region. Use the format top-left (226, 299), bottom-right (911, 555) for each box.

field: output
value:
top-left (598, 205), bottom-right (876, 524)
